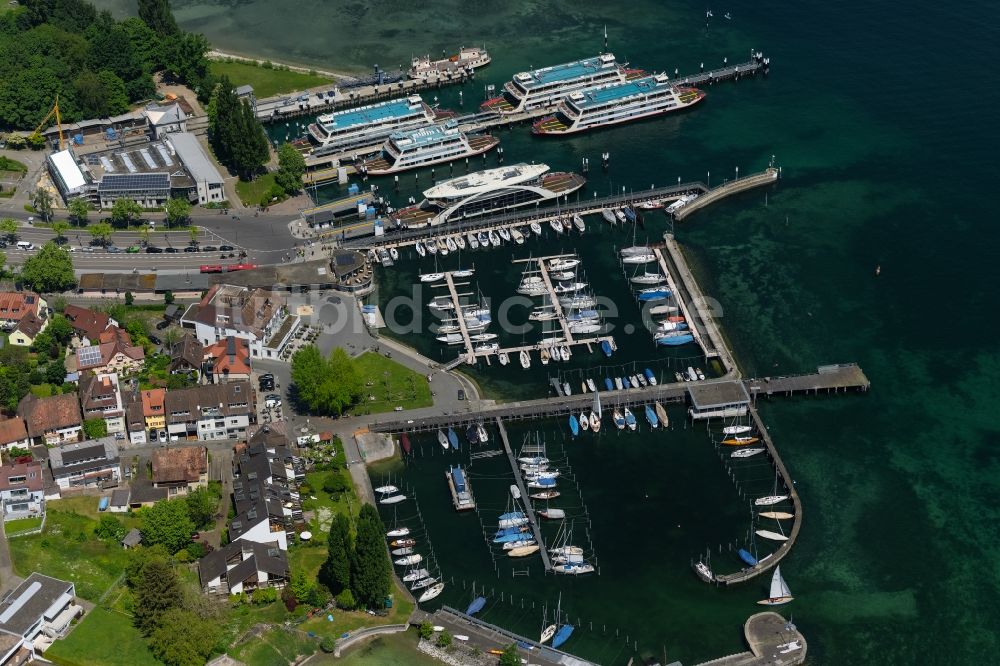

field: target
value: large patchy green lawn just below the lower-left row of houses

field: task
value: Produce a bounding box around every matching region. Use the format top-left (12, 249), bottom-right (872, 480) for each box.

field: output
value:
top-left (10, 497), bottom-right (136, 601)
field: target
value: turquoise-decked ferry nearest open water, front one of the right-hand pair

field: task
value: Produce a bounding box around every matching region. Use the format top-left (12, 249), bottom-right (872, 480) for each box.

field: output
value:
top-left (531, 74), bottom-right (705, 134)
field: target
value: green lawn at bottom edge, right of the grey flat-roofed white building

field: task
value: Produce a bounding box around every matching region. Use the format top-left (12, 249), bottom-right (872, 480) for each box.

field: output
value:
top-left (45, 607), bottom-right (160, 666)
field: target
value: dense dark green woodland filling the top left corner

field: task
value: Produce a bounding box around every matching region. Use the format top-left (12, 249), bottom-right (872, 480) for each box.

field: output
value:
top-left (0, 0), bottom-right (211, 129)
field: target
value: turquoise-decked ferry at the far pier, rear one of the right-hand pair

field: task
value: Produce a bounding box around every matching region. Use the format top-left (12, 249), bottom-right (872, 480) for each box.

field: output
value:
top-left (481, 53), bottom-right (643, 114)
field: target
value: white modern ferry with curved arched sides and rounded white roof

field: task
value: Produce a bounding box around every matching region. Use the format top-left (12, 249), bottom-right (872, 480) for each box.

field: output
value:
top-left (392, 164), bottom-right (586, 229)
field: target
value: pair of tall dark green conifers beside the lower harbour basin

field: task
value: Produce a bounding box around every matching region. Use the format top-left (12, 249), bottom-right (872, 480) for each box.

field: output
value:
top-left (319, 504), bottom-right (392, 608)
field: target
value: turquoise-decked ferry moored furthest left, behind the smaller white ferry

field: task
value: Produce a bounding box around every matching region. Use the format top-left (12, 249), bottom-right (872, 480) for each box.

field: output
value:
top-left (307, 95), bottom-right (438, 155)
